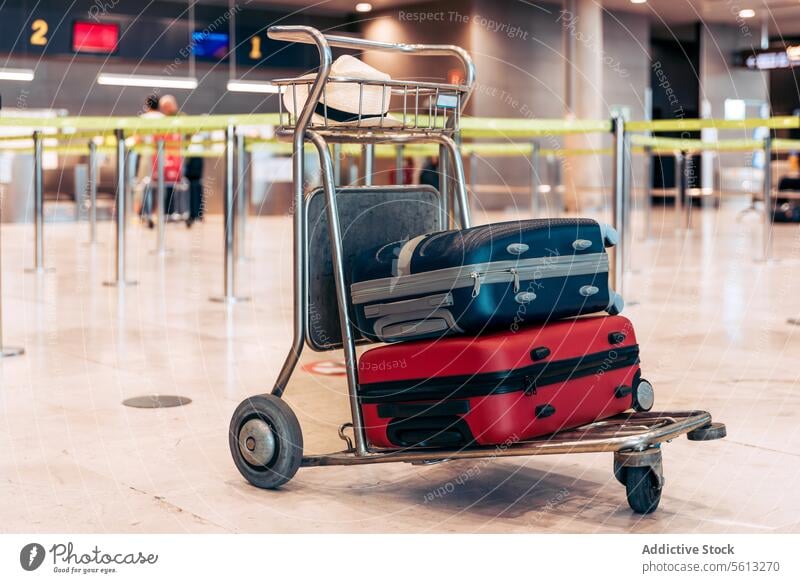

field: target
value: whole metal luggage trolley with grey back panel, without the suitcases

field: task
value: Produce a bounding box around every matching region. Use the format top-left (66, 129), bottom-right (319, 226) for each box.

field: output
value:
top-left (229, 26), bottom-right (725, 513)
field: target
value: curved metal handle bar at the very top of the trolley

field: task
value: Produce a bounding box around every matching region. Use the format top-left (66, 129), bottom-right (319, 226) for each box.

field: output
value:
top-left (267, 26), bottom-right (475, 96)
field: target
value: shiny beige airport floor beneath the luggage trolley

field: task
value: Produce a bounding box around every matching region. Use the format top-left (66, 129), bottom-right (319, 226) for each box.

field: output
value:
top-left (0, 208), bottom-right (800, 533)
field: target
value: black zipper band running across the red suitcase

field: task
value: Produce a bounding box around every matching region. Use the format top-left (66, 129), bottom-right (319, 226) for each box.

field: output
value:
top-left (359, 344), bottom-right (639, 403)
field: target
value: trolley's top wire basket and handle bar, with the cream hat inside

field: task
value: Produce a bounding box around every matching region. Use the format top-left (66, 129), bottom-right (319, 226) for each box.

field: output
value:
top-left (268, 26), bottom-right (475, 136)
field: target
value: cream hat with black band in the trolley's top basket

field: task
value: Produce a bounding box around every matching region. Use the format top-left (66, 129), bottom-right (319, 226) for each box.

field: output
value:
top-left (283, 55), bottom-right (400, 127)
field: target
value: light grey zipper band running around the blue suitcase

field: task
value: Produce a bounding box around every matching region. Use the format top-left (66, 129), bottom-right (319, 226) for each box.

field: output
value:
top-left (350, 253), bottom-right (608, 304)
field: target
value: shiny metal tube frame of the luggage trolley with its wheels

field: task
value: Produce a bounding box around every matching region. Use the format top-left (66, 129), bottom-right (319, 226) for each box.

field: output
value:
top-left (229, 26), bottom-right (725, 512)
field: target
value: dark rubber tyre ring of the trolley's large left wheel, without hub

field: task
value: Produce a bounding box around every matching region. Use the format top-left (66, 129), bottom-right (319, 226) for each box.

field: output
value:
top-left (233, 395), bottom-right (303, 489)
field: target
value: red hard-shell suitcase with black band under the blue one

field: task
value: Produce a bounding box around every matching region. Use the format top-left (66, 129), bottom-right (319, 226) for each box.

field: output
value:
top-left (358, 316), bottom-right (653, 448)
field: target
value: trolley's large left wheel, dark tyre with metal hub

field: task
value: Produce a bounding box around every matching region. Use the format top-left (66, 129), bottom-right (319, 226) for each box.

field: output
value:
top-left (228, 395), bottom-right (303, 489)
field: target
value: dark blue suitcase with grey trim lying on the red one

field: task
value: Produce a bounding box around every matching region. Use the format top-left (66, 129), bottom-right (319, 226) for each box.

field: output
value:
top-left (350, 219), bottom-right (623, 342)
